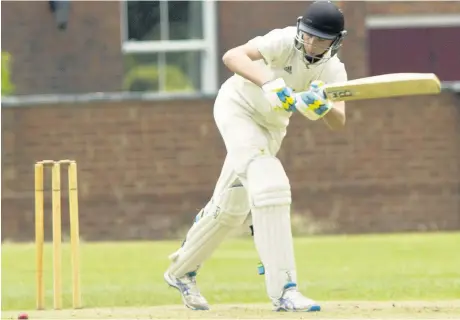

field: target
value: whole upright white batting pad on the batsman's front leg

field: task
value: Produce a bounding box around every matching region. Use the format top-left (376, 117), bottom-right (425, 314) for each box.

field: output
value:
top-left (247, 156), bottom-right (297, 299)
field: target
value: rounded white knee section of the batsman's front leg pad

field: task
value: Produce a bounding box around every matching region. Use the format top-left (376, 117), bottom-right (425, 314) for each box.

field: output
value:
top-left (247, 156), bottom-right (291, 207)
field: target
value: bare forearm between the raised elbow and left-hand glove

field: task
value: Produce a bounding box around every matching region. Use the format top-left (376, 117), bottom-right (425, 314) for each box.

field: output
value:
top-left (222, 50), bottom-right (273, 87)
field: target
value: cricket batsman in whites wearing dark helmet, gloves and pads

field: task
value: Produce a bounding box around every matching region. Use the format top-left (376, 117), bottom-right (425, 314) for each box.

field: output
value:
top-left (164, 1), bottom-right (347, 311)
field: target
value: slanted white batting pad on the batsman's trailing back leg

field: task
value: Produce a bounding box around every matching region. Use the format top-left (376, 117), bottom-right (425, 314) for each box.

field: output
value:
top-left (169, 186), bottom-right (249, 277)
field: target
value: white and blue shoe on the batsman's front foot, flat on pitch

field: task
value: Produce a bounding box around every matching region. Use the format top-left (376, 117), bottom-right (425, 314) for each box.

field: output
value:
top-left (273, 282), bottom-right (321, 312)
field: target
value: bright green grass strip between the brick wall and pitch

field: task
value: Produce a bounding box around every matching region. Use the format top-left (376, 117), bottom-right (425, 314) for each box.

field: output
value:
top-left (2, 233), bottom-right (460, 319)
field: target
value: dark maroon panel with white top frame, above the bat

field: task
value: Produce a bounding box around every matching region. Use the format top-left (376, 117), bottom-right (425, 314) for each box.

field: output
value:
top-left (367, 15), bottom-right (460, 81)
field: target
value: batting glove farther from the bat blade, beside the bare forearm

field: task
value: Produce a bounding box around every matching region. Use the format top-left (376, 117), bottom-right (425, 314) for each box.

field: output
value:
top-left (262, 78), bottom-right (296, 111)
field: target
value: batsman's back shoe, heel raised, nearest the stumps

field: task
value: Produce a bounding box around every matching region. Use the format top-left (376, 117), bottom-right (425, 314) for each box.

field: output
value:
top-left (164, 271), bottom-right (209, 310)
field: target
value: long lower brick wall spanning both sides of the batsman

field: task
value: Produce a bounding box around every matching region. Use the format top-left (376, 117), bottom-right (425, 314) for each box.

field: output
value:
top-left (2, 94), bottom-right (460, 240)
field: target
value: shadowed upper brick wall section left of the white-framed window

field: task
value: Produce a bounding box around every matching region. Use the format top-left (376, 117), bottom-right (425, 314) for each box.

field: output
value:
top-left (2, 1), bottom-right (123, 94)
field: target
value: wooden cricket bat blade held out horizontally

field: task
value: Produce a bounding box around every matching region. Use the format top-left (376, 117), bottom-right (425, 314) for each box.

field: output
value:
top-left (323, 73), bottom-right (441, 101)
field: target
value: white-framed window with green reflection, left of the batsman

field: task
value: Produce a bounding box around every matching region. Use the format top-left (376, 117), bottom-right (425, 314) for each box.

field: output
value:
top-left (122, 0), bottom-right (218, 94)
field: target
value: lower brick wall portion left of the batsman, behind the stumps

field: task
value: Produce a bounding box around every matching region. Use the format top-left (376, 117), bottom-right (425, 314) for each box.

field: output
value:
top-left (2, 101), bottom-right (223, 239)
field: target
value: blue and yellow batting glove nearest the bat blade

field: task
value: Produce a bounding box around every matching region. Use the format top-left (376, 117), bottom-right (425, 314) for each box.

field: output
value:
top-left (295, 80), bottom-right (334, 121)
